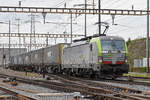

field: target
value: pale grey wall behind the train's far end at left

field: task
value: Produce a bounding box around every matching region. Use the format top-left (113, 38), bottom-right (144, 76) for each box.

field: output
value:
top-left (0, 48), bottom-right (27, 66)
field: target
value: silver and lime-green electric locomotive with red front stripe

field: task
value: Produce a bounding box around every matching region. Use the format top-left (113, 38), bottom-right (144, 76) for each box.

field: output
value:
top-left (62, 36), bottom-right (129, 78)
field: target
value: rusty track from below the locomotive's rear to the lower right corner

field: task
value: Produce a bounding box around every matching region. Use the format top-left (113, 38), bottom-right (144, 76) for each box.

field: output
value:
top-left (47, 75), bottom-right (150, 99)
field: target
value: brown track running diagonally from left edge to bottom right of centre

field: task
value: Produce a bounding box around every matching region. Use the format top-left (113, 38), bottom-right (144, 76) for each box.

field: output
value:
top-left (0, 74), bottom-right (125, 100)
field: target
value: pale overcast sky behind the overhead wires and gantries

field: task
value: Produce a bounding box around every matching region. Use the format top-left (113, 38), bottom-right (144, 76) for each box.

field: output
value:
top-left (0, 0), bottom-right (146, 46)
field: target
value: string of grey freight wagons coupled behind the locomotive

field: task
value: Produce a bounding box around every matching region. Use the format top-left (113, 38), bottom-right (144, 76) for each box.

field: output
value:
top-left (9, 43), bottom-right (67, 73)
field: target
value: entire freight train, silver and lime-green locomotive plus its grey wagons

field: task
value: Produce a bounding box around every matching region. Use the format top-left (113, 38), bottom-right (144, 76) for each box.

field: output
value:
top-left (9, 36), bottom-right (129, 78)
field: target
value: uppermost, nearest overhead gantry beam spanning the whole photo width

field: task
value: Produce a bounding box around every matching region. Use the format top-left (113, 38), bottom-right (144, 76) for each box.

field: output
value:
top-left (0, 6), bottom-right (150, 16)
